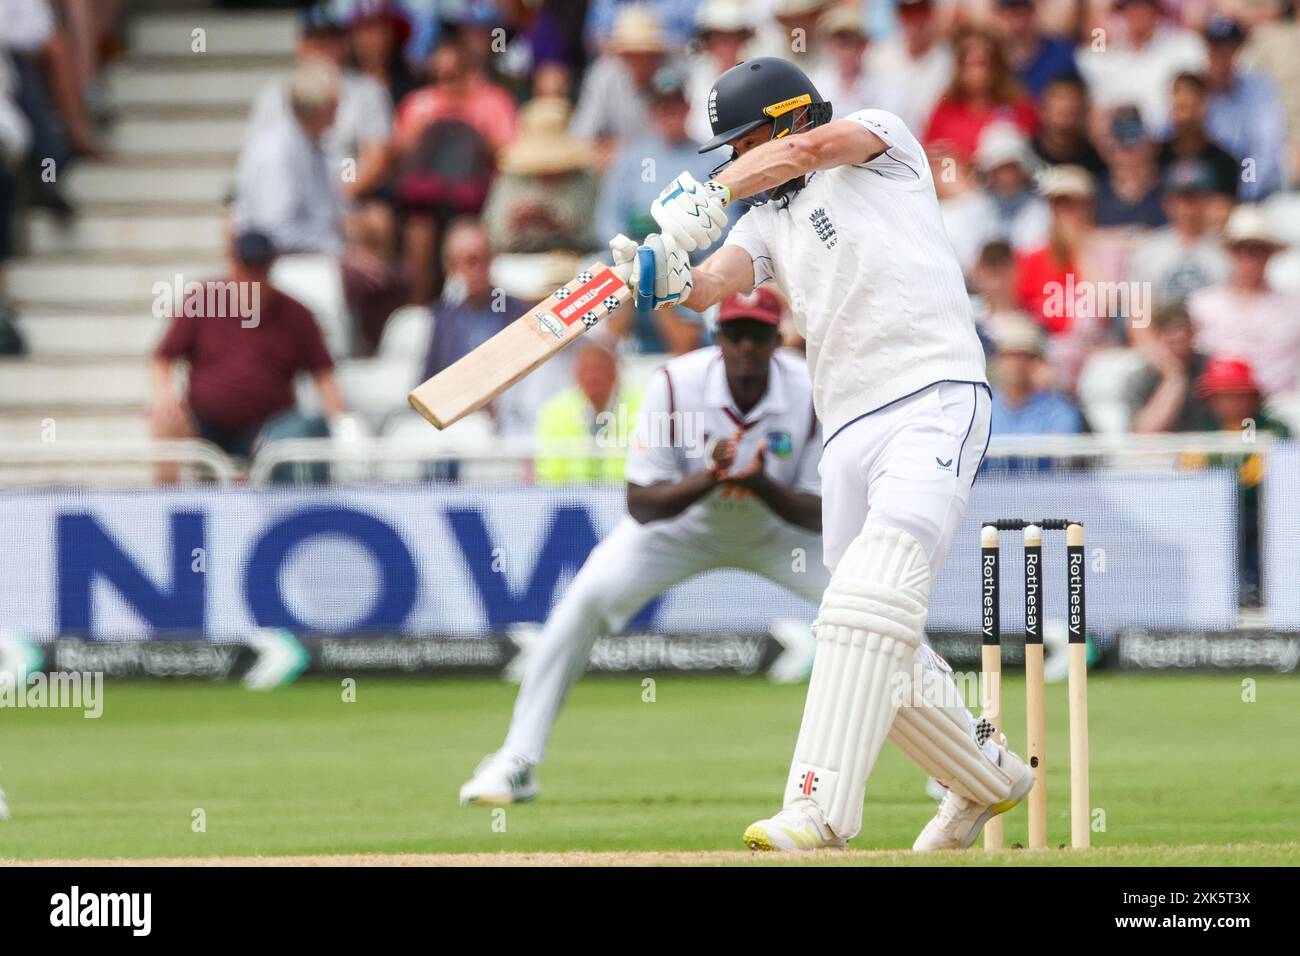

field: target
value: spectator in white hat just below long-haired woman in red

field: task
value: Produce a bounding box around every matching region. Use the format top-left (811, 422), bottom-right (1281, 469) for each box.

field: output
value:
top-left (975, 122), bottom-right (1052, 256)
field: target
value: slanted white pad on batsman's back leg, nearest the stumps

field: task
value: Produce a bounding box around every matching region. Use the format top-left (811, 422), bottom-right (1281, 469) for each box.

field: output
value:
top-left (889, 646), bottom-right (1013, 804)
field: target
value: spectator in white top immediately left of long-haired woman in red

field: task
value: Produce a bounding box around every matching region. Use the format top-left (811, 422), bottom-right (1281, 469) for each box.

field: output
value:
top-left (867, 0), bottom-right (953, 135)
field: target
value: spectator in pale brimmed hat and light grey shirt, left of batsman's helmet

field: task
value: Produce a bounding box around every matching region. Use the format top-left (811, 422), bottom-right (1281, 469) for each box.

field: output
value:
top-left (572, 5), bottom-right (668, 170)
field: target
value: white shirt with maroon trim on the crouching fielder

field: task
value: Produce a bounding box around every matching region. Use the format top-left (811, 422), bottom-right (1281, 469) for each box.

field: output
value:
top-left (624, 346), bottom-right (822, 546)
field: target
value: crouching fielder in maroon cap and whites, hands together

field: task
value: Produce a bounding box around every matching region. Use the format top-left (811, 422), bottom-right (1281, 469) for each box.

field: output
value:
top-left (460, 290), bottom-right (828, 804)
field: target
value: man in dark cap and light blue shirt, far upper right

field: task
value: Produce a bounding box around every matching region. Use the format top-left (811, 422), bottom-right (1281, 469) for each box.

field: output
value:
top-left (1205, 14), bottom-right (1284, 203)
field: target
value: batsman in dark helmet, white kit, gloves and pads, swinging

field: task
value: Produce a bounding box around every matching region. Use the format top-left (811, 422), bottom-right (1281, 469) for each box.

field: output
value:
top-left (629, 57), bottom-right (1034, 849)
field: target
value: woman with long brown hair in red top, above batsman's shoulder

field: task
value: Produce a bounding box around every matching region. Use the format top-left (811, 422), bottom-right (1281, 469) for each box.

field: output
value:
top-left (924, 30), bottom-right (1037, 160)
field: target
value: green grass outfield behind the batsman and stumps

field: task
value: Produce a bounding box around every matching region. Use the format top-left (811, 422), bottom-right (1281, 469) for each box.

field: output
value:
top-left (0, 675), bottom-right (1300, 865)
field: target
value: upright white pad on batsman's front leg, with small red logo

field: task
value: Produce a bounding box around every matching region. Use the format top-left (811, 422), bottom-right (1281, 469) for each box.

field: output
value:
top-left (785, 525), bottom-right (930, 839)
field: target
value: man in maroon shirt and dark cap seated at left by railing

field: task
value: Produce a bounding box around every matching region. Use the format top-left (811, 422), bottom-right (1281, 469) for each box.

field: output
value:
top-left (150, 233), bottom-right (343, 484)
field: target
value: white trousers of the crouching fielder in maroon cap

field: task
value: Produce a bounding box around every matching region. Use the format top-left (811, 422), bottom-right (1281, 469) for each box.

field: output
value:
top-left (504, 518), bottom-right (828, 763)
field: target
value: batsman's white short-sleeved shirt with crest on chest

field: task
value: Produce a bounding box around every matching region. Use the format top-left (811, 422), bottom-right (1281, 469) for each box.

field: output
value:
top-left (727, 109), bottom-right (987, 441)
